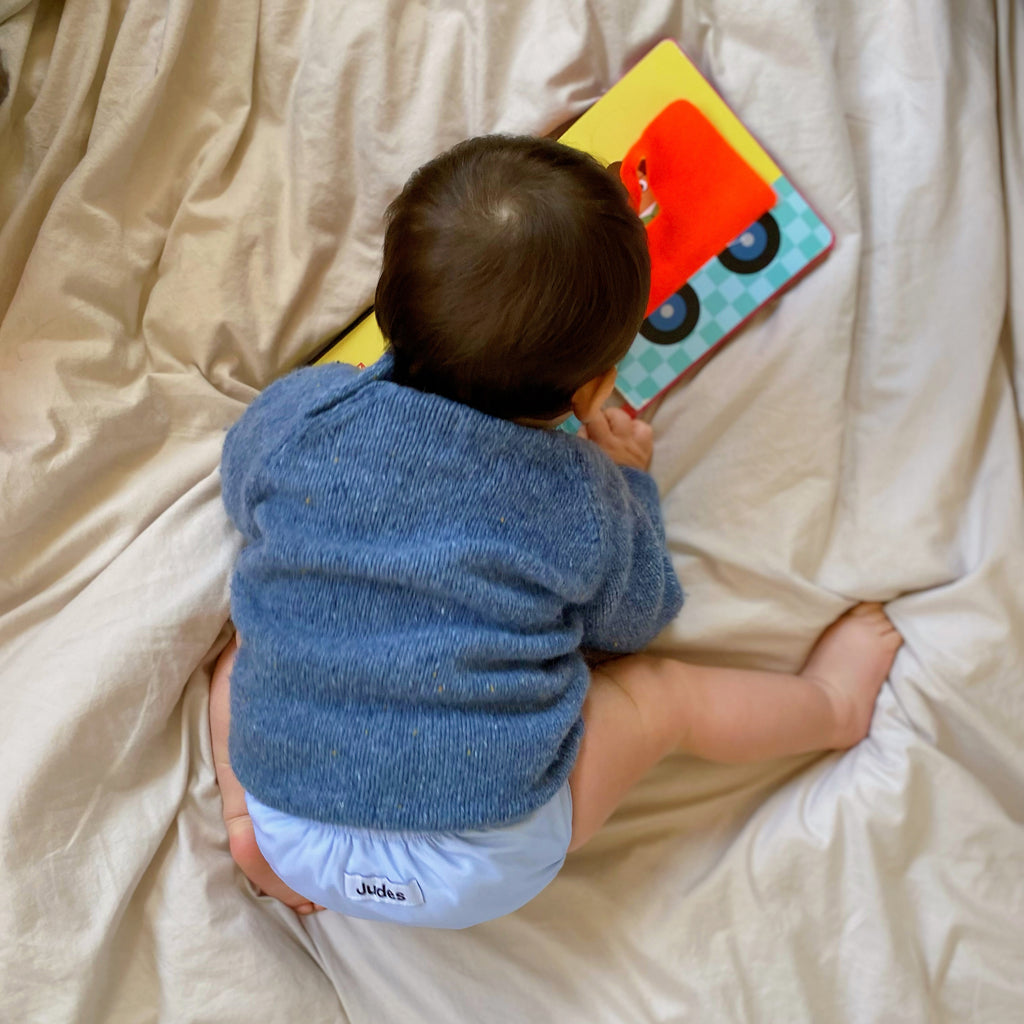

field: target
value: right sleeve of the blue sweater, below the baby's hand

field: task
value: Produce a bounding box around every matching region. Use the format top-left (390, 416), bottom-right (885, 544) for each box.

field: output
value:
top-left (583, 454), bottom-right (683, 653)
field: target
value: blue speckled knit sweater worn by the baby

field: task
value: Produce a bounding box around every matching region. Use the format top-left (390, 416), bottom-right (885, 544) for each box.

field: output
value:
top-left (222, 356), bottom-right (682, 831)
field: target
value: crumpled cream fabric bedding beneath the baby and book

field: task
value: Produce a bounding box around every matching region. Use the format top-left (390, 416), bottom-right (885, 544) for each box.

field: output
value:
top-left (0, 0), bottom-right (1024, 1024)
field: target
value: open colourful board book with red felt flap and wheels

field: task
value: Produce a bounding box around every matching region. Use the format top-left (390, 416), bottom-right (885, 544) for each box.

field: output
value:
top-left (317, 40), bottom-right (835, 413)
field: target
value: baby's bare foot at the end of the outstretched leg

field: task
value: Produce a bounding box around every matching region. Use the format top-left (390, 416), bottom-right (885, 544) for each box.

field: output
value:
top-left (801, 602), bottom-right (903, 750)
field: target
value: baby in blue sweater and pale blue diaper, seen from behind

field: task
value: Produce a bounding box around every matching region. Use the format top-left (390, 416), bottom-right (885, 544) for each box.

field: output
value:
top-left (210, 136), bottom-right (900, 928)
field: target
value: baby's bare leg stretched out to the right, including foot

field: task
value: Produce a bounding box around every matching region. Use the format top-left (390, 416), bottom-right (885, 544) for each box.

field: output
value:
top-left (569, 604), bottom-right (902, 850)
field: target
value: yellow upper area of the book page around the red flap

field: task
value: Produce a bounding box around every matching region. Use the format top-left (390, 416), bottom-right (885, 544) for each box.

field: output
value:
top-left (561, 40), bottom-right (782, 184)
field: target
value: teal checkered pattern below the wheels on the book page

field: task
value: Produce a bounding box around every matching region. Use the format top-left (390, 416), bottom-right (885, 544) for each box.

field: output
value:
top-left (616, 177), bottom-right (833, 409)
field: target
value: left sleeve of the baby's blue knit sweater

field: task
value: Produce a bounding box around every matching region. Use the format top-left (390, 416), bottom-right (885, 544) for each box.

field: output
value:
top-left (220, 364), bottom-right (358, 542)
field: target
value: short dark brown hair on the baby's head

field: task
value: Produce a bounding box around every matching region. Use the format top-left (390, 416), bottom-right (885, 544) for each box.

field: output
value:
top-left (375, 135), bottom-right (650, 419)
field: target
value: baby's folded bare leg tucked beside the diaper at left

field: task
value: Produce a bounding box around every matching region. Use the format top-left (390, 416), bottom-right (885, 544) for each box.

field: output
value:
top-left (210, 637), bottom-right (324, 914)
